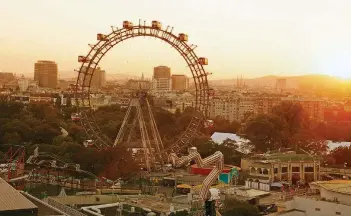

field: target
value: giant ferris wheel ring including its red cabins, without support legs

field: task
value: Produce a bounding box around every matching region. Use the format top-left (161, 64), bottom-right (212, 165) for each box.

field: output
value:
top-left (75, 20), bottom-right (212, 170)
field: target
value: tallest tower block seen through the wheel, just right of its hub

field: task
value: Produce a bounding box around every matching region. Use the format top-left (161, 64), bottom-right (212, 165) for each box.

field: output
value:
top-left (152, 66), bottom-right (172, 92)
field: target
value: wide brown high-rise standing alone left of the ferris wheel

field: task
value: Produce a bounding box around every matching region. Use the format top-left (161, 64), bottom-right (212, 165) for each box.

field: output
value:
top-left (34, 61), bottom-right (57, 88)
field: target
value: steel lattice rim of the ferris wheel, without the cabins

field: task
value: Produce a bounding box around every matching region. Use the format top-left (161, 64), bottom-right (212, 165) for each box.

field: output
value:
top-left (75, 20), bottom-right (209, 152)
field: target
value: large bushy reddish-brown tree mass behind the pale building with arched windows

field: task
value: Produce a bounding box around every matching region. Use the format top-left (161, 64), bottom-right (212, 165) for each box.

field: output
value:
top-left (242, 102), bottom-right (327, 153)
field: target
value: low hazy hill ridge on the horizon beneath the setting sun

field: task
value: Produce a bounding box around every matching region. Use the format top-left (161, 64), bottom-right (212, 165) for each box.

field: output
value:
top-left (209, 74), bottom-right (351, 88)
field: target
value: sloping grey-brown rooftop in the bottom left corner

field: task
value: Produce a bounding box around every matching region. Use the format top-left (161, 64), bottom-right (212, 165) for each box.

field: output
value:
top-left (0, 178), bottom-right (37, 211)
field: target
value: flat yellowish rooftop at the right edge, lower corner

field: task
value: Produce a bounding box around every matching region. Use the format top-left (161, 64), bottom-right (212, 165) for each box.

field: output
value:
top-left (310, 180), bottom-right (351, 195)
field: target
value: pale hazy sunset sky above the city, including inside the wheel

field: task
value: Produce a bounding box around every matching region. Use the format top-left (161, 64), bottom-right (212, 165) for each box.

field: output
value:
top-left (0, 0), bottom-right (351, 78)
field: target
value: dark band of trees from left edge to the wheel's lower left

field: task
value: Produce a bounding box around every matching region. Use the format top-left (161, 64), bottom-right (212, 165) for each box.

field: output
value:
top-left (0, 100), bottom-right (143, 179)
